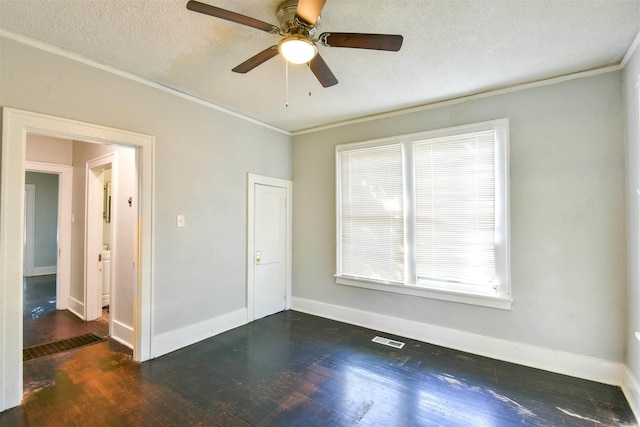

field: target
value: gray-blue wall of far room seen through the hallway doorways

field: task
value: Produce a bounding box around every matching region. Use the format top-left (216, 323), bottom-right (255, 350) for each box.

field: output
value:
top-left (25, 172), bottom-right (58, 268)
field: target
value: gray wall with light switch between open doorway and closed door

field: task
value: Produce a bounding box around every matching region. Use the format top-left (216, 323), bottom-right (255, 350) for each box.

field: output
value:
top-left (0, 38), bottom-right (291, 335)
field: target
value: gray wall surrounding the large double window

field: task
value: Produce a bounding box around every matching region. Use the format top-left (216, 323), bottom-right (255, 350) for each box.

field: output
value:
top-left (293, 72), bottom-right (627, 362)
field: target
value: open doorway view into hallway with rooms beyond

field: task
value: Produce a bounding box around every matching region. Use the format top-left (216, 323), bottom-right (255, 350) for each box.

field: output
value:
top-left (23, 134), bottom-right (138, 367)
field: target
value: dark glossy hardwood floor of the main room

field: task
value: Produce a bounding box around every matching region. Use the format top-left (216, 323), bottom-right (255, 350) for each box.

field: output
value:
top-left (0, 302), bottom-right (637, 426)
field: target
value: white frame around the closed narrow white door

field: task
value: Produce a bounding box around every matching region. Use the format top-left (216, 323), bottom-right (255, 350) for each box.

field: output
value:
top-left (247, 173), bottom-right (293, 322)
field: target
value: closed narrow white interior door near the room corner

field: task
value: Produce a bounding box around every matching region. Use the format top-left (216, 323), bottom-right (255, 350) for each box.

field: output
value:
top-left (253, 184), bottom-right (287, 319)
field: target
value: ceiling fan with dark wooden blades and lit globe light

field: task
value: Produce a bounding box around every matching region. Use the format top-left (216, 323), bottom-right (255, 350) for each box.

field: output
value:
top-left (187, 0), bottom-right (402, 87)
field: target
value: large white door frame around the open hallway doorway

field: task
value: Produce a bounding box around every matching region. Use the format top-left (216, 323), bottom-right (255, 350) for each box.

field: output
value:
top-left (0, 107), bottom-right (155, 411)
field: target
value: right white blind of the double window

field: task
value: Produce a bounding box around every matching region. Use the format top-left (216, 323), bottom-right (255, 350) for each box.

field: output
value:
top-left (414, 130), bottom-right (496, 286)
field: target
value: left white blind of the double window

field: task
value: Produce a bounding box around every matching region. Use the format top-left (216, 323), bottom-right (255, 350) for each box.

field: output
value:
top-left (339, 144), bottom-right (404, 283)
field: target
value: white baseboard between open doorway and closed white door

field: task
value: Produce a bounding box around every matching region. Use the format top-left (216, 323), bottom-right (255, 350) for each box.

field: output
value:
top-left (151, 308), bottom-right (247, 358)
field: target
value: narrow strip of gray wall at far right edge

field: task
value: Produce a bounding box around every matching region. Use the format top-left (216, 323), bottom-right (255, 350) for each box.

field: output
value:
top-left (624, 42), bottom-right (640, 393)
